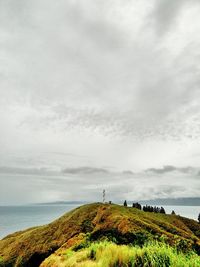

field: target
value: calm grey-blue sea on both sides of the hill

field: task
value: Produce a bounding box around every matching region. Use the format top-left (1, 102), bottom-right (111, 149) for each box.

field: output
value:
top-left (0, 204), bottom-right (200, 239)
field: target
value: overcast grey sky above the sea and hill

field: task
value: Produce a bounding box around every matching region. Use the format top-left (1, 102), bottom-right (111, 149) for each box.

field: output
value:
top-left (0, 0), bottom-right (200, 205)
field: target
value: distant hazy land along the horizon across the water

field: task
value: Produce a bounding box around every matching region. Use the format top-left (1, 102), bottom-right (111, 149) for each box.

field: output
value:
top-left (37, 197), bottom-right (200, 206)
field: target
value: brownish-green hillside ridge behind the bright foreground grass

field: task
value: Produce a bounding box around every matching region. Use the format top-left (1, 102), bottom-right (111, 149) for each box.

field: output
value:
top-left (0, 203), bottom-right (200, 267)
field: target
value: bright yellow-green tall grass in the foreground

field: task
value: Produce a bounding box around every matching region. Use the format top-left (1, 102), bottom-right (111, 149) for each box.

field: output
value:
top-left (41, 241), bottom-right (200, 267)
